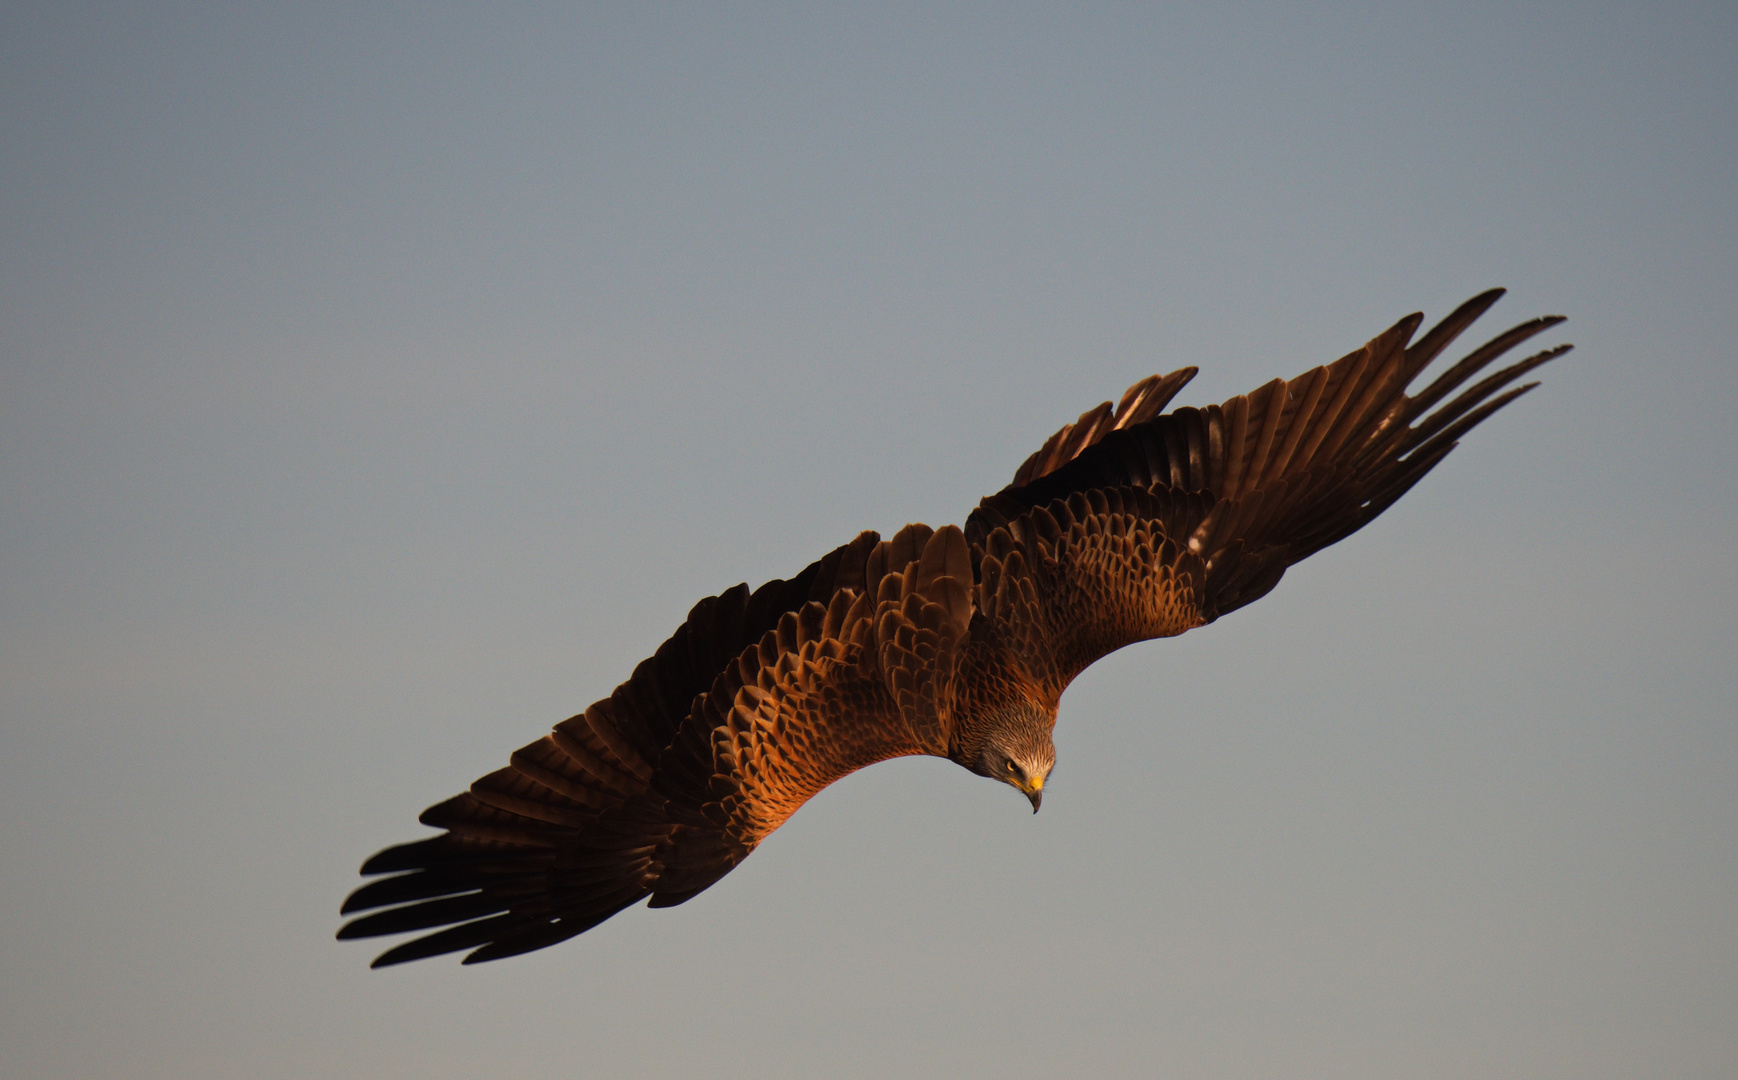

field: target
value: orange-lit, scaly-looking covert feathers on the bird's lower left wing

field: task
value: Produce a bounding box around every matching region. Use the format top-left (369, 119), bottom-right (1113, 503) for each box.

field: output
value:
top-left (653, 525), bottom-right (973, 876)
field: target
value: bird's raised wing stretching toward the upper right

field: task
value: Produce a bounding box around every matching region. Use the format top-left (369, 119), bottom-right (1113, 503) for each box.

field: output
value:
top-left (966, 289), bottom-right (1569, 692)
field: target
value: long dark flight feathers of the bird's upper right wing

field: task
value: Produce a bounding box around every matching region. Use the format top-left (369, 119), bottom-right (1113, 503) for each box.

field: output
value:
top-left (966, 289), bottom-right (1569, 640)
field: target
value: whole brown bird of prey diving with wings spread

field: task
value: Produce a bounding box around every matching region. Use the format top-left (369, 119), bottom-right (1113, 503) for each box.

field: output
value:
top-left (339, 290), bottom-right (1569, 967)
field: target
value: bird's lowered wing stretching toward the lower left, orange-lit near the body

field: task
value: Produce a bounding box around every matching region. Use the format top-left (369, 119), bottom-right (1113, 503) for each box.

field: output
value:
top-left (339, 525), bottom-right (972, 967)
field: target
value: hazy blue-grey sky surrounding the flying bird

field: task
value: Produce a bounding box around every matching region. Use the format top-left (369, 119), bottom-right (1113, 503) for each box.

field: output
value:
top-left (0, 3), bottom-right (1738, 1080)
